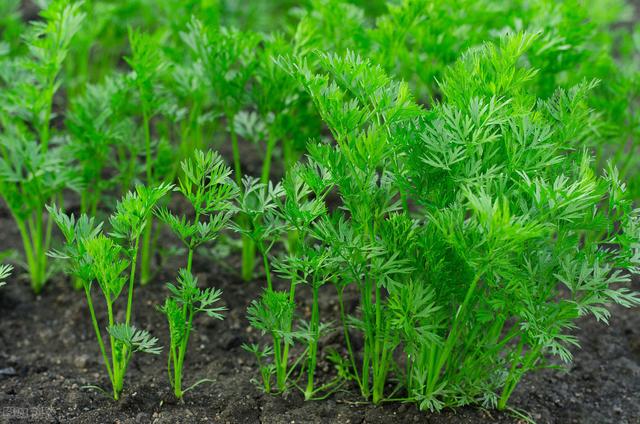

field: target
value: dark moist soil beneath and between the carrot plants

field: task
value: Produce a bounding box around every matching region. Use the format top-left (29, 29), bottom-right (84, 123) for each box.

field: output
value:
top-left (0, 211), bottom-right (640, 424)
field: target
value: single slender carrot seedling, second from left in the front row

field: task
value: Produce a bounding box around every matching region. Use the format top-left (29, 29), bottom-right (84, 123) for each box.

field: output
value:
top-left (157, 150), bottom-right (237, 399)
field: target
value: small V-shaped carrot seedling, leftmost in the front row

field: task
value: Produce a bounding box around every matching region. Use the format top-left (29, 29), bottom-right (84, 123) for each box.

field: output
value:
top-left (48, 185), bottom-right (171, 400)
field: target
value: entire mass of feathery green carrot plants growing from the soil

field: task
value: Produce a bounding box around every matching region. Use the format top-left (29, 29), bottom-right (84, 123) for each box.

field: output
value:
top-left (0, 0), bottom-right (640, 418)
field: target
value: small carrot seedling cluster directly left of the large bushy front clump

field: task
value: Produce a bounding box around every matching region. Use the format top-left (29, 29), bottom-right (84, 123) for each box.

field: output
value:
top-left (238, 166), bottom-right (341, 399)
